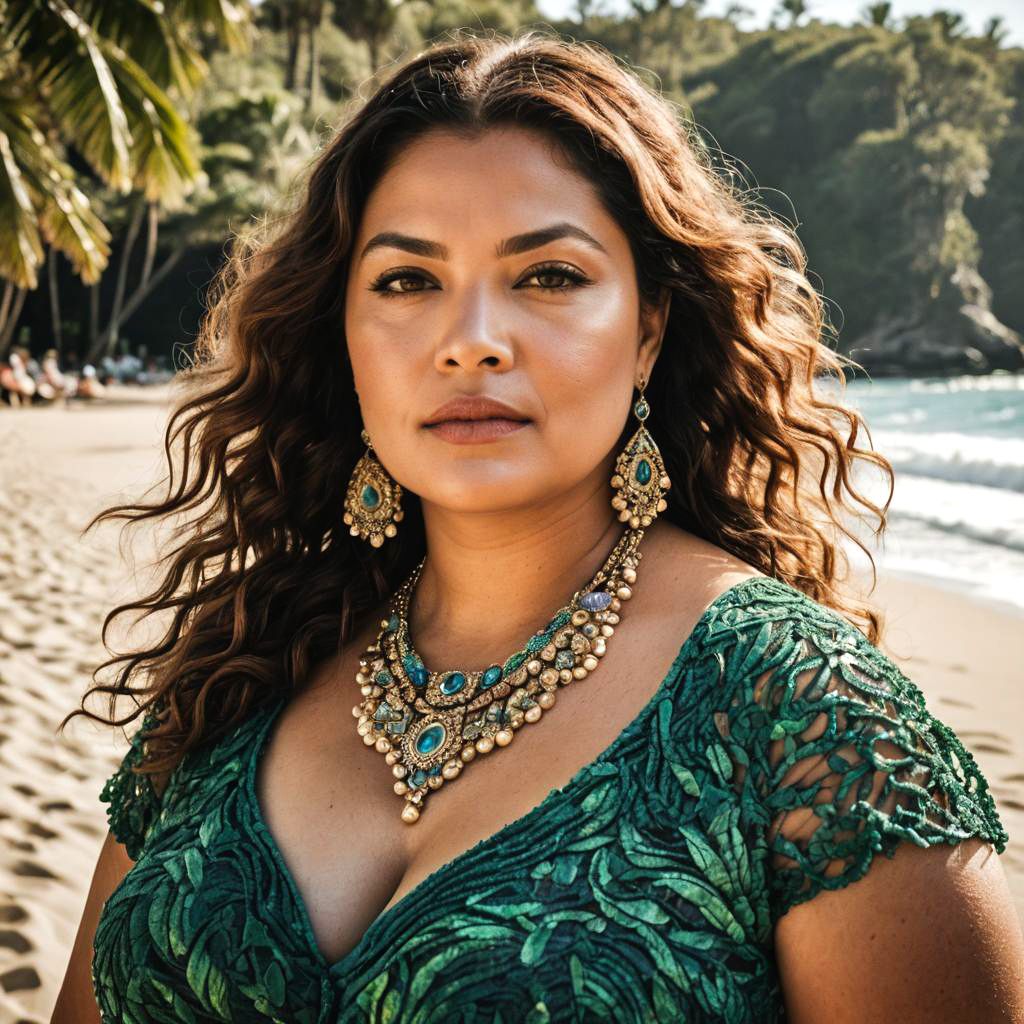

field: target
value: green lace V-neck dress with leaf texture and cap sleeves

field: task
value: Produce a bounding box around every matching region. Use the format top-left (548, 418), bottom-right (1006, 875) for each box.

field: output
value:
top-left (92, 578), bottom-right (1009, 1024)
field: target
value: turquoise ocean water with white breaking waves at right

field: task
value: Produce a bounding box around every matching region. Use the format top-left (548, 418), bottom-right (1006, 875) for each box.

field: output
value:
top-left (846, 374), bottom-right (1024, 611)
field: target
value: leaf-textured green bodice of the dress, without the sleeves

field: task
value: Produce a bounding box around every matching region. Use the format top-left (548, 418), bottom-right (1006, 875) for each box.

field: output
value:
top-left (94, 679), bottom-right (779, 1024)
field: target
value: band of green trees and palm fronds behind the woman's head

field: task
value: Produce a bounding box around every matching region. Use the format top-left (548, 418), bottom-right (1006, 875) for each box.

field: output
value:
top-left (8, 0), bottom-right (1024, 372)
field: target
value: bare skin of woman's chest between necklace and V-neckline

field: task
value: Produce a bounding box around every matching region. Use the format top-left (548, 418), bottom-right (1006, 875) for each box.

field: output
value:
top-left (254, 602), bottom-right (704, 964)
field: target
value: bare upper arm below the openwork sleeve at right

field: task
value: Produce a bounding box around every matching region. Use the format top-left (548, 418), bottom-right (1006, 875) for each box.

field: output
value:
top-left (774, 839), bottom-right (1024, 1024)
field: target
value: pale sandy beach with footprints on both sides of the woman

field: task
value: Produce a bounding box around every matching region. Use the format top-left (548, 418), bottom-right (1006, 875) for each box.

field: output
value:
top-left (0, 388), bottom-right (1024, 1024)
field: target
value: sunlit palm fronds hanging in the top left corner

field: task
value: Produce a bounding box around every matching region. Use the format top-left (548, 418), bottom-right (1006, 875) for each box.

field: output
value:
top-left (0, 0), bottom-right (248, 354)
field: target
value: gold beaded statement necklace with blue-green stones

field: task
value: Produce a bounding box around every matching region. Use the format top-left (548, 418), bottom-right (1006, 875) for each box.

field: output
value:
top-left (352, 526), bottom-right (644, 824)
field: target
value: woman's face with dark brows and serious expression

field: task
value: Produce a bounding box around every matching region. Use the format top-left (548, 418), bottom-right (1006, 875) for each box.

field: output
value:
top-left (345, 127), bottom-right (668, 520)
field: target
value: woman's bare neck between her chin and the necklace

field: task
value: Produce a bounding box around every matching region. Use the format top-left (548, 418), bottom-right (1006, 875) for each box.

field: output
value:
top-left (409, 466), bottom-right (625, 671)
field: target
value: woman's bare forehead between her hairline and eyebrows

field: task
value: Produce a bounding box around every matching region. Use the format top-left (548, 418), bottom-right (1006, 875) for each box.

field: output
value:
top-left (359, 127), bottom-right (617, 238)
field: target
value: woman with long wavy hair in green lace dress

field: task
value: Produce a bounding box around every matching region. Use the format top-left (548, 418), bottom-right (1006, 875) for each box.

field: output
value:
top-left (54, 32), bottom-right (1022, 1024)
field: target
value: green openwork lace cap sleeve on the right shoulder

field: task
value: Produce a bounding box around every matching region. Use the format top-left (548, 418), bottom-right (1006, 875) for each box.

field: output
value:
top-left (751, 598), bottom-right (1009, 922)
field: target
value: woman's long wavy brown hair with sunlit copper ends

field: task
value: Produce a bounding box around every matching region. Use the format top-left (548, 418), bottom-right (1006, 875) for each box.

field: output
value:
top-left (59, 29), bottom-right (893, 773)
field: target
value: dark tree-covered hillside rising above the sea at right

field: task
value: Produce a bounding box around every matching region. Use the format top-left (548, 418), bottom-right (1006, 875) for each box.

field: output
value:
top-left (682, 14), bottom-right (1024, 346)
